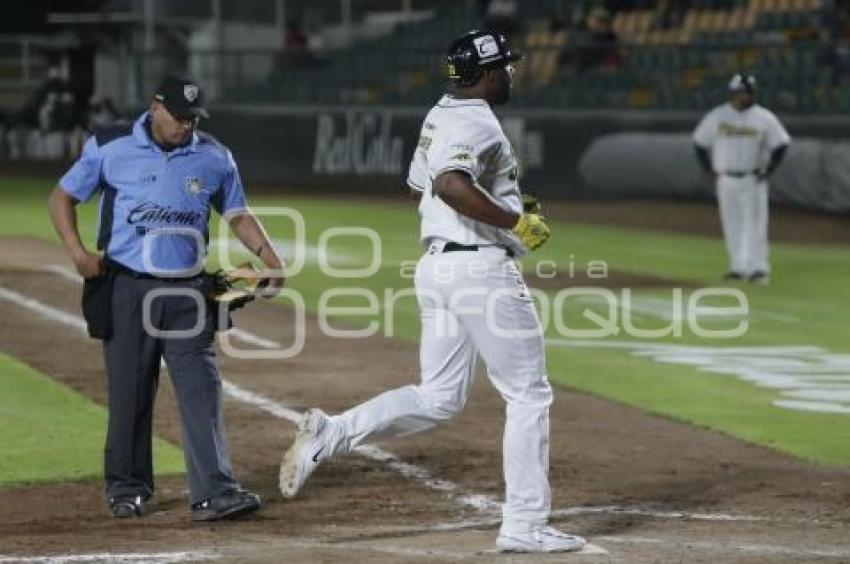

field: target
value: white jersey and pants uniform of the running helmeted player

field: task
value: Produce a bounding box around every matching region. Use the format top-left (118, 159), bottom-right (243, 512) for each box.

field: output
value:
top-left (314, 91), bottom-right (552, 534)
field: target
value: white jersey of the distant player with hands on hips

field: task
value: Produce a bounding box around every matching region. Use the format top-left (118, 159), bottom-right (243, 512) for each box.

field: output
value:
top-left (694, 103), bottom-right (791, 174)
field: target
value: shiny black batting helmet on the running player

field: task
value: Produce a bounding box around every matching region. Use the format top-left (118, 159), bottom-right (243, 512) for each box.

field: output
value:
top-left (446, 30), bottom-right (523, 86)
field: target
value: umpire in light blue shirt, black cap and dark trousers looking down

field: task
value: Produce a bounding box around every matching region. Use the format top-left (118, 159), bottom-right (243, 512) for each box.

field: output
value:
top-left (49, 76), bottom-right (284, 521)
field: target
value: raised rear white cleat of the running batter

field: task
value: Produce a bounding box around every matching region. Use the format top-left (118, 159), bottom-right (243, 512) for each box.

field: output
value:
top-left (278, 409), bottom-right (328, 498)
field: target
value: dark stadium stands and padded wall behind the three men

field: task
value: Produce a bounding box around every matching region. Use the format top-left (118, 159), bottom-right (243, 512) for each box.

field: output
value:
top-left (0, 0), bottom-right (850, 214)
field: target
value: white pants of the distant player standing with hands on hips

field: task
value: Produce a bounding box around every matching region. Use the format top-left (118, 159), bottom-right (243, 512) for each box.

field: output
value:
top-left (717, 175), bottom-right (770, 276)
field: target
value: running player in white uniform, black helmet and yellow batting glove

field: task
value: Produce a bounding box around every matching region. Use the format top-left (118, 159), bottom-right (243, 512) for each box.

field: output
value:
top-left (280, 32), bottom-right (585, 552)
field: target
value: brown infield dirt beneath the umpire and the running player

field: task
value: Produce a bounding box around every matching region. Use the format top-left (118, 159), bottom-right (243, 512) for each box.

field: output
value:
top-left (0, 239), bottom-right (850, 563)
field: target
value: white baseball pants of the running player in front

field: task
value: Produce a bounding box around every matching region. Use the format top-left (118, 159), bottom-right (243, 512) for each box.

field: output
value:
top-left (326, 242), bottom-right (552, 532)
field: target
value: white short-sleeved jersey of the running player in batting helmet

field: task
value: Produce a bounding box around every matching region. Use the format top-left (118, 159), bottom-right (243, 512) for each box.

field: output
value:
top-left (407, 94), bottom-right (525, 256)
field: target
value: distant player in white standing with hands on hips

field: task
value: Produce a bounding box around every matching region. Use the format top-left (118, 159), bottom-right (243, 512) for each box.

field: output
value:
top-left (694, 74), bottom-right (791, 284)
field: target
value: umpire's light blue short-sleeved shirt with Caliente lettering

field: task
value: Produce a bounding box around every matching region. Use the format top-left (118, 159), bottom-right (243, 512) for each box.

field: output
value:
top-left (59, 113), bottom-right (247, 276)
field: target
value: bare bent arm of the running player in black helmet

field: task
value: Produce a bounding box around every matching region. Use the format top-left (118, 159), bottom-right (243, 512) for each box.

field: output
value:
top-left (434, 170), bottom-right (520, 229)
